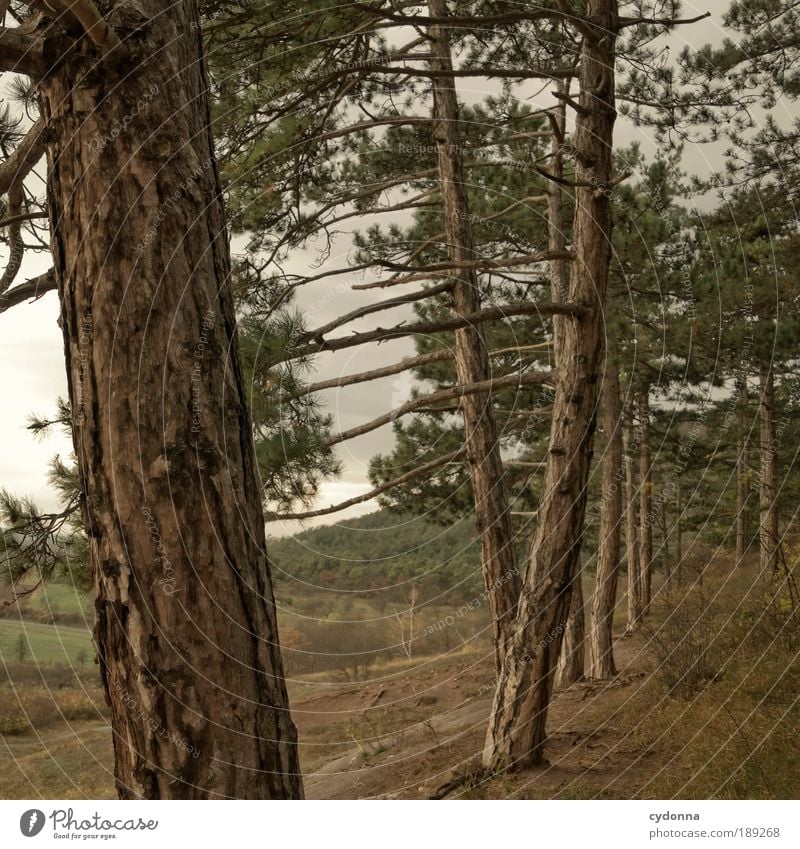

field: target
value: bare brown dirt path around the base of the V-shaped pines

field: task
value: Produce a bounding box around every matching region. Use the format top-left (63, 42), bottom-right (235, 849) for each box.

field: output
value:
top-left (293, 638), bottom-right (650, 799)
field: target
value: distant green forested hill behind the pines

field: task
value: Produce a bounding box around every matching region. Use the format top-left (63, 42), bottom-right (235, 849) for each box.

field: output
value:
top-left (268, 510), bottom-right (483, 596)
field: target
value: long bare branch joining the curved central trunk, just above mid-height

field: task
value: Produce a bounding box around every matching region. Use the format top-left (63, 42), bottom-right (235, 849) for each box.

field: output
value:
top-left (282, 302), bottom-right (587, 365)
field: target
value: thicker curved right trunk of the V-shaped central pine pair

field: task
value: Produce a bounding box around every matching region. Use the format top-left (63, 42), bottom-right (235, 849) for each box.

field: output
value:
top-left (483, 0), bottom-right (617, 769)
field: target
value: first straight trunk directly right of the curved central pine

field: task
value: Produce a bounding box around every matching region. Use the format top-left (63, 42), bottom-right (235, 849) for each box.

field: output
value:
top-left (589, 359), bottom-right (625, 679)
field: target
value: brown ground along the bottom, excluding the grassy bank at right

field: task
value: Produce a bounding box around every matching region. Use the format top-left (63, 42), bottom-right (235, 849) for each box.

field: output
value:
top-left (0, 637), bottom-right (651, 799)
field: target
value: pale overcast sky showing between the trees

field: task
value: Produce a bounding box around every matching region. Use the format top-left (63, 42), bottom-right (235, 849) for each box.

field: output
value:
top-left (0, 0), bottom-right (788, 534)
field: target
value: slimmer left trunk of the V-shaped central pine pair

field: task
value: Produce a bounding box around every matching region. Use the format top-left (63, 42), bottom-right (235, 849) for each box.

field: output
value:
top-left (428, 0), bottom-right (521, 668)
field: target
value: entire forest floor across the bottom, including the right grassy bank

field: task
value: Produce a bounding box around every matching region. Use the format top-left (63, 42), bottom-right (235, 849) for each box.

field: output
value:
top-left (0, 564), bottom-right (800, 799)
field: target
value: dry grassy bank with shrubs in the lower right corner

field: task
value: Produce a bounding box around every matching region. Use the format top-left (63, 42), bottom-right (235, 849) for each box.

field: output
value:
top-left (616, 562), bottom-right (800, 799)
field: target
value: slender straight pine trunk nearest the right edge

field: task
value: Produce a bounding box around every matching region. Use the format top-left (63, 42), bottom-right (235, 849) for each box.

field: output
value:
top-left (758, 363), bottom-right (779, 575)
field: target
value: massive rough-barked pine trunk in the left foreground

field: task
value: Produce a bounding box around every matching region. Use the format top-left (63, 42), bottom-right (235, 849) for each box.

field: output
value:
top-left (39, 0), bottom-right (302, 799)
